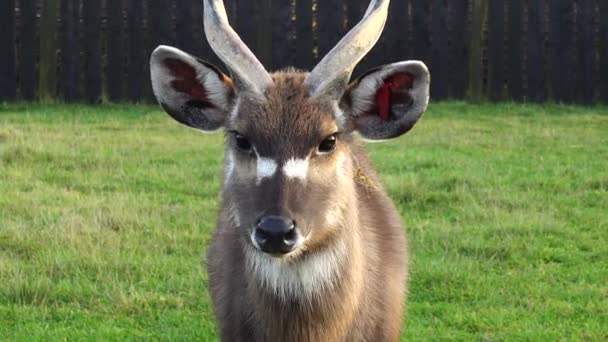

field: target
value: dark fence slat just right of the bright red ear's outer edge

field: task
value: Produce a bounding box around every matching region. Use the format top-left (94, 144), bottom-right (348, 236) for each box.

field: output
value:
top-left (430, 0), bottom-right (449, 100)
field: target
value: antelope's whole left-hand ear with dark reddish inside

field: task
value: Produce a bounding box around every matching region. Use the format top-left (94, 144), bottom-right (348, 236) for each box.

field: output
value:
top-left (150, 45), bottom-right (234, 132)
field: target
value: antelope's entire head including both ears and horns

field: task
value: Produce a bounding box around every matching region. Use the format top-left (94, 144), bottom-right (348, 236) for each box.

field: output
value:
top-left (150, 0), bottom-right (430, 255)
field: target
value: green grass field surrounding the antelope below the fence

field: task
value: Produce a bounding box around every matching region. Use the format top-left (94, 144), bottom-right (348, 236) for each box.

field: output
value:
top-left (0, 103), bottom-right (608, 341)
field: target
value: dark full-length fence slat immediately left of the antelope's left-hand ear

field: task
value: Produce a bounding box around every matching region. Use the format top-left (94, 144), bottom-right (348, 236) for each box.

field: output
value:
top-left (127, 0), bottom-right (146, 102)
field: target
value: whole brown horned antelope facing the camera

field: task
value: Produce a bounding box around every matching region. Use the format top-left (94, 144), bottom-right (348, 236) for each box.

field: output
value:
top-left (150, 0), bottom-right (430, 341)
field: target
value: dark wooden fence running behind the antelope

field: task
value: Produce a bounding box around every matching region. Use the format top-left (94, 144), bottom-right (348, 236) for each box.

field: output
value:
top-left (0, 0), bottom-right (608, 104)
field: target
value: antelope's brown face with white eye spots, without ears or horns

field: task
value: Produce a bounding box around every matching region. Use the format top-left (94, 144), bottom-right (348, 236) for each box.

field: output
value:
top-left (224, 72), bottom-right (353, 254)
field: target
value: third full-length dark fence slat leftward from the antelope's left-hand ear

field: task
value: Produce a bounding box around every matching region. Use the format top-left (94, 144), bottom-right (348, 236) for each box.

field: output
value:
top-left (83, 0), bottom-right (102, 103)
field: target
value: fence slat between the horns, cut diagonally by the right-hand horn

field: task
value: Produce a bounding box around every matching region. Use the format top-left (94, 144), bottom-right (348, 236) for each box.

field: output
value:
top-left (315, 0), bottom-right (344, 63)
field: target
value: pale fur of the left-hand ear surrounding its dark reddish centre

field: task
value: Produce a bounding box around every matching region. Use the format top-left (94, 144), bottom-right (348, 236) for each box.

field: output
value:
top-left (150, 45), bottom-right (232, 131)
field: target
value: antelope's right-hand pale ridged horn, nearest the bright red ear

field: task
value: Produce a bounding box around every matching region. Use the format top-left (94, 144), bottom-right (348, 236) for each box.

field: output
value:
top-left (304, 0), bottom-right (390, 96)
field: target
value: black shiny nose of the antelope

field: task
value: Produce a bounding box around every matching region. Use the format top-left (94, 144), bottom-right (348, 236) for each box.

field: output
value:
top-left (254, 215), bottom-right (298, 254)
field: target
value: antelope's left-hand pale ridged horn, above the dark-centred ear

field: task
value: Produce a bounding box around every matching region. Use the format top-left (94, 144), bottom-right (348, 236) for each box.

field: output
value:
top-left (203, 0), bottom-right (273, 94)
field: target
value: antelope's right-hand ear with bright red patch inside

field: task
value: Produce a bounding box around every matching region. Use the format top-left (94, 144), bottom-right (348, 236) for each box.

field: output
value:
top-left (341, 61), bottom-right (431, 140)
